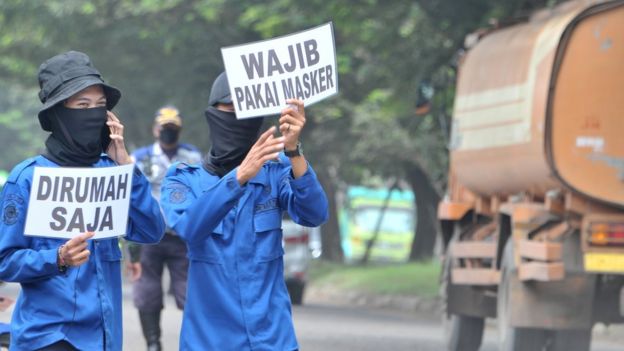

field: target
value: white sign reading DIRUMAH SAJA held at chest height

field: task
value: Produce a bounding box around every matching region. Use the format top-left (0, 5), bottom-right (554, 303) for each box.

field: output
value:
top-left (24, 164), bottom-right (134, 239)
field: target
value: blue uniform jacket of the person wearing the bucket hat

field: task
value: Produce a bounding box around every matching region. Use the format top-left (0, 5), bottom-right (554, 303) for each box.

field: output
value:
top-left (0, 155), bottom-right (165, 351)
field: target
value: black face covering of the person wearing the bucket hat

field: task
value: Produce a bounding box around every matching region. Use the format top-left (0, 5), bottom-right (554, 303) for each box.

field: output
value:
top-left (45, 104), bottom-right (110, 167)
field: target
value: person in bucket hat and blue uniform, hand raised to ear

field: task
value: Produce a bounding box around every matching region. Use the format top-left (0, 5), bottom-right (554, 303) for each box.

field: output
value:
top-left (0, 51), bottom-right (165, 350)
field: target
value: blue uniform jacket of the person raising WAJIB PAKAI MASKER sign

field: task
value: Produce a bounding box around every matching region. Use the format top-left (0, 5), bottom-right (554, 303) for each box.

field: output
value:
top-left (161, 161), bottom-right (328, 351)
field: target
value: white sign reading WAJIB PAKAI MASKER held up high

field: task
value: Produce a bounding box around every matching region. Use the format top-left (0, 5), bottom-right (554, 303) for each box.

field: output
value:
top-left (221, 22), bottom-right (338, 119)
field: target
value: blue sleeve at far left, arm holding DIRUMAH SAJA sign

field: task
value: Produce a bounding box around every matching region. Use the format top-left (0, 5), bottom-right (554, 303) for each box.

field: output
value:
top-left (0, 176), bottom-right (61, 283)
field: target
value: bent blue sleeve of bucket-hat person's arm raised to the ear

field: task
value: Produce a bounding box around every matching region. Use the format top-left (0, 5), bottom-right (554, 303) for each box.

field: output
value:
top-left (126, 167), bottom-right (165, 244)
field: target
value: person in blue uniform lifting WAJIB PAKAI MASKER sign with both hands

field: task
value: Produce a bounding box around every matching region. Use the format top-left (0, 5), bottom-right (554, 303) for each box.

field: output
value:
top-left (161, 73), bottom-right (328, 351)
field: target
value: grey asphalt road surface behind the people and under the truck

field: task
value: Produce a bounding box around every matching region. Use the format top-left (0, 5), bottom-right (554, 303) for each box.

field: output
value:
top-left (0, 284), bottom-right (624, 351)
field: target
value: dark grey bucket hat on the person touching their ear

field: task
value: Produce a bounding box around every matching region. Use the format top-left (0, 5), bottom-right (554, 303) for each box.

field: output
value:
top-left (38, 51), bottom-right (121, 131)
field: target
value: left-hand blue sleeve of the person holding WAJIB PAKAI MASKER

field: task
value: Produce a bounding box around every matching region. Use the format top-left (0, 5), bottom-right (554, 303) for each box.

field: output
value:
top-left (160, 166), bottom-right (245, 243)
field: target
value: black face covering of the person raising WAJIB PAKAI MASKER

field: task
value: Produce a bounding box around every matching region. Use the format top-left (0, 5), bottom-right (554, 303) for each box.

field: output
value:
top-left (203, 106), bottom-right (262, 177)
